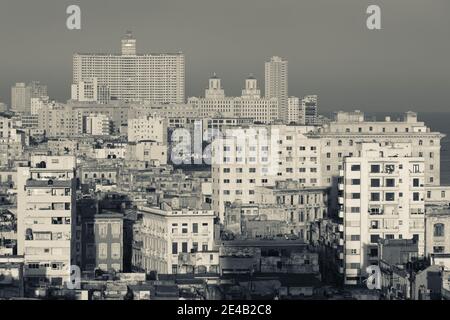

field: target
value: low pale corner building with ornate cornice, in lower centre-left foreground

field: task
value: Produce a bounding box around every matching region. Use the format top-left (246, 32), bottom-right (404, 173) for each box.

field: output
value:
top-left (133, 203), bottom-right (217, 274)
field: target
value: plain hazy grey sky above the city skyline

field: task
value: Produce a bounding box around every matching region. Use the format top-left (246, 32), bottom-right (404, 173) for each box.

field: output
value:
top-left (0, 0), bottom-right (450, 112)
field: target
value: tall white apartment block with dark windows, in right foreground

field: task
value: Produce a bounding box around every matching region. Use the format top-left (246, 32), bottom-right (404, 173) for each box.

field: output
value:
top-left (339, 143), bottom-right (425, 284)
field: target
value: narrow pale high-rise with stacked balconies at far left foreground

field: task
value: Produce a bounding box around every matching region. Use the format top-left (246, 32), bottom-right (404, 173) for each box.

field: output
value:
top-left (17, 155), bottom-right (77, 285)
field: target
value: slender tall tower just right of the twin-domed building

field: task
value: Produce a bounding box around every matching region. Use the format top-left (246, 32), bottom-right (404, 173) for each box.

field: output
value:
top-left (265, 56), bottom-right (288, 122)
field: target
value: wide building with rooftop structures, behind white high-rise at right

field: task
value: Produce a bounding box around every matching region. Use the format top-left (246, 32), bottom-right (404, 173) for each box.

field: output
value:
top-left (307, 111), bottom-right (444, 215)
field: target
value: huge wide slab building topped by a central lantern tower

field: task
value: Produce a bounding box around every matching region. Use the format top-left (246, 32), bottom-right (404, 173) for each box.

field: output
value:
top-left (73, 32), bottom-right (185, 103)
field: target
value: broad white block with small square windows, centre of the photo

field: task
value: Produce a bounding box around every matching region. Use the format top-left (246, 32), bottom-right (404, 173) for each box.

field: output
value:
top-left (211, 125), bottom-right (321, 221)
